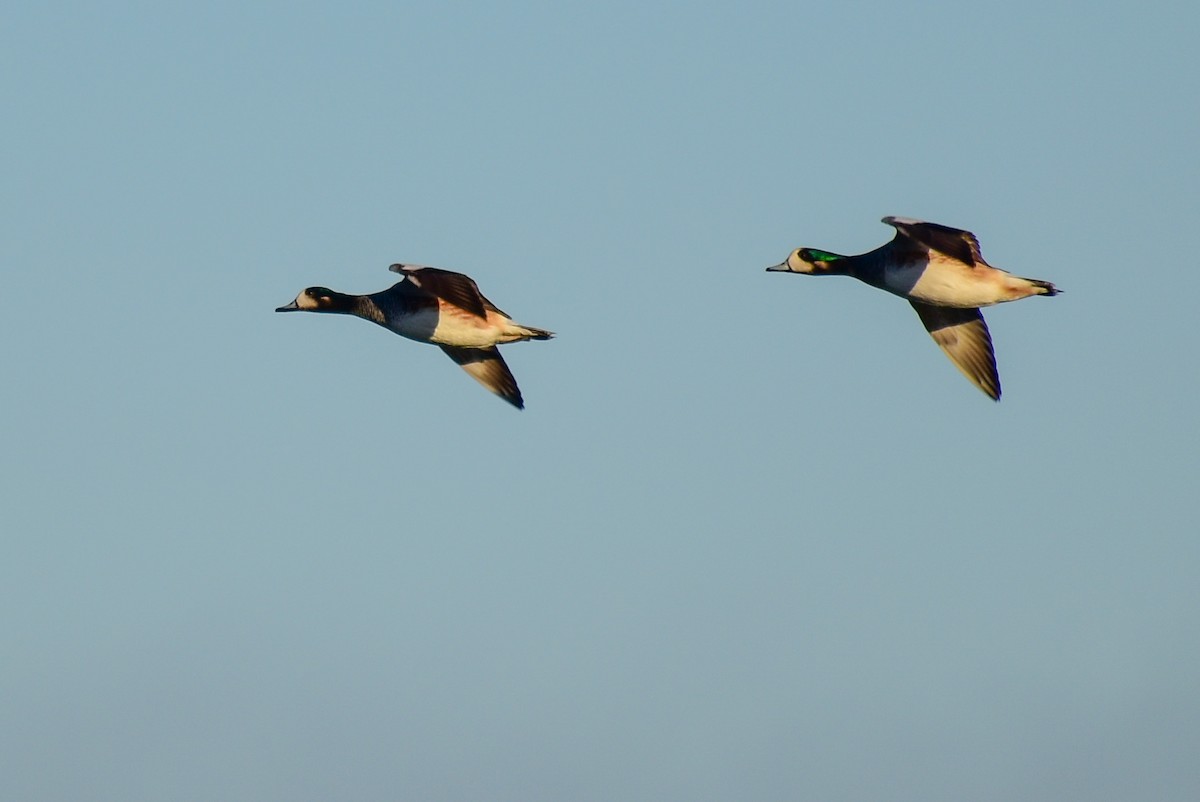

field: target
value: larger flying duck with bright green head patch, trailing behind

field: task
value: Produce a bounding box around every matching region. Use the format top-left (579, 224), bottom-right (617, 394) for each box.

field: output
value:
top-left (767, 216), bottom-right (1062, 401)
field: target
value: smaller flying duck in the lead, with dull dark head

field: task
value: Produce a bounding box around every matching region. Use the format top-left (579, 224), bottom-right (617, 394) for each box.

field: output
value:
top-left (275, 264), bottom-right (554, 409)
